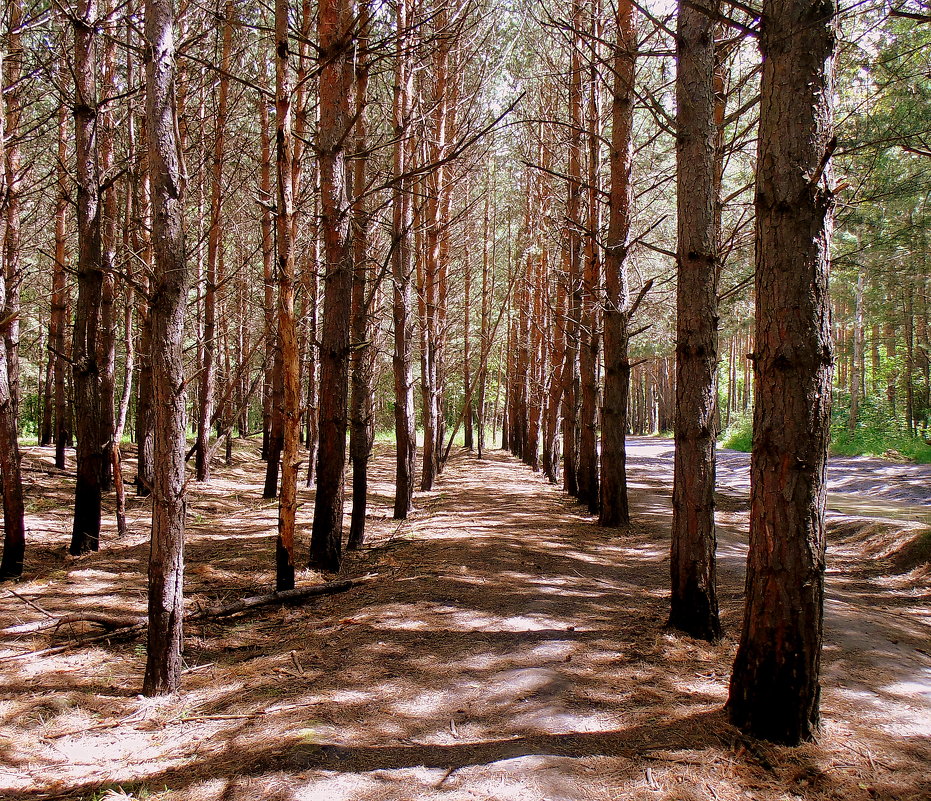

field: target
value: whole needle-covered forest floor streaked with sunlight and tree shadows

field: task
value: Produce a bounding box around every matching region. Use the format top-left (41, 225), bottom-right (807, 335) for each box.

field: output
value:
top-left (0, 438), bottom-right (931, 801)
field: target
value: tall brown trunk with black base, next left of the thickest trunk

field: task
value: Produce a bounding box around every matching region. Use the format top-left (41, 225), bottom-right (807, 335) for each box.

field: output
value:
top-left (669, 0), bottom-right (721, 640)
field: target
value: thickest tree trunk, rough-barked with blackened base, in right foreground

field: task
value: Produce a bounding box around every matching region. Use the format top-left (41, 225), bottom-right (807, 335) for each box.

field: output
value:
top-left (728, 0), bottom-right (837, 744)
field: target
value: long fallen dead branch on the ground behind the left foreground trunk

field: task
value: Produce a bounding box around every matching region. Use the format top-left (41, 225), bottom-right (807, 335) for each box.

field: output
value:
top-left (0, 573), bottom-right (378, 662)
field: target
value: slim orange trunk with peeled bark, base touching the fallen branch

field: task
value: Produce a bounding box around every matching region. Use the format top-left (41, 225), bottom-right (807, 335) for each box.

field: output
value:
top-left (275, 0), bottom-right (301, 592)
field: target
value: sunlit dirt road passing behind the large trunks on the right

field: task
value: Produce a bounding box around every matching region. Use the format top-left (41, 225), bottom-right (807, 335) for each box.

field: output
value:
top-left (628, 437), bottom-right (931, 737)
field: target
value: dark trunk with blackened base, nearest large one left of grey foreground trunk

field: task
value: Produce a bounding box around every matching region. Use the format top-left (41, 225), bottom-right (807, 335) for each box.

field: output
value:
top-left (70, 0), bottom-right (106, 555)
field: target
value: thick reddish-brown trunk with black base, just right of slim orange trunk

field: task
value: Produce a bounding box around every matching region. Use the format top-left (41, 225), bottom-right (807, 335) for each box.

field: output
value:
top-left (310, 0), bottom-right (355, 571)
